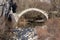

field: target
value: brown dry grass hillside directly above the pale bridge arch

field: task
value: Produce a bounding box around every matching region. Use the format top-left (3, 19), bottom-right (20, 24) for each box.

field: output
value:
top-left (16, 0), bottom-right (53, 12)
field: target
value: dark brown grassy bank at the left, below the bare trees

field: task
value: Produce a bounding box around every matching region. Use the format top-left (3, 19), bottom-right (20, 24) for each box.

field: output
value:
top-left (0, 16), bottom-right (13, 40)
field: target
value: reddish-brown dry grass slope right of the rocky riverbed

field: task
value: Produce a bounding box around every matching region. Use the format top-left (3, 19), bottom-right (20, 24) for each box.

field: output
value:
top-left (37, 18), bottom-right (60, 40)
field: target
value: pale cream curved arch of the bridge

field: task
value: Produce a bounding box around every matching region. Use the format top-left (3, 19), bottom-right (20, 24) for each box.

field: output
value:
top-left (15, 8), bottom-right (48, 22)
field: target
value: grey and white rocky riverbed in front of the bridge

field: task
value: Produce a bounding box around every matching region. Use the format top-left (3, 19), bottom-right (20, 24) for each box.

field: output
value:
top-left (13, 28), bottom-right (38, 40)
